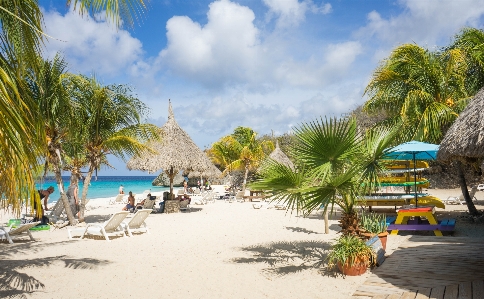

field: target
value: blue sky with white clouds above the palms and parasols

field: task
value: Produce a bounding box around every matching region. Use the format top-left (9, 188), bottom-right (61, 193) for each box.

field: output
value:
top-left (39, 0), bottom-right (484, 175)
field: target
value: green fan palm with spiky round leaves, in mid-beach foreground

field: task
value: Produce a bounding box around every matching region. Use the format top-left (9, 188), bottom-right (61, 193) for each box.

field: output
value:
top-left (250, 119), bottom-right (396, 234)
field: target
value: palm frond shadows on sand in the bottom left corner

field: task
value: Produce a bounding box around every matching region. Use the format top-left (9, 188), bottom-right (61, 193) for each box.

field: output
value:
top-left (0, 244), bottom-right (110, 298)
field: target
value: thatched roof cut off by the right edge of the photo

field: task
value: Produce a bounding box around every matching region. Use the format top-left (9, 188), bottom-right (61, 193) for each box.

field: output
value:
top-left (437, 88), bottom-right (484, 161)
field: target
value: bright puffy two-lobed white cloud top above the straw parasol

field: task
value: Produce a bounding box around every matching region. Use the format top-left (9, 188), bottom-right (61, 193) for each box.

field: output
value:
top-left (160, 0), bottom-right (261, 86)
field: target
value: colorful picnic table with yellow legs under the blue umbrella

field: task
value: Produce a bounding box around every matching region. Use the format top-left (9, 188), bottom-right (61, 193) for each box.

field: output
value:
top-left (387, 207), bottom-right (455, 236)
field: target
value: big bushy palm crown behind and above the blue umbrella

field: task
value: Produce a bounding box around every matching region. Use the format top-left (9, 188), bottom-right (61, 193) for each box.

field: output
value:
top-left (364, 44), bottom-right (470, 143)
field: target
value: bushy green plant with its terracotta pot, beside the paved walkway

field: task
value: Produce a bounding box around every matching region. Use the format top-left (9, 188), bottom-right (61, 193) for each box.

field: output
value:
top-left (327, 235), bottom-right (374, 276)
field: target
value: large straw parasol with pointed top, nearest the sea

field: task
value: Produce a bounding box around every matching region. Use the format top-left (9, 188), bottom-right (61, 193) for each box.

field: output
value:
top-left (127, 100), bottom-right (213, 194)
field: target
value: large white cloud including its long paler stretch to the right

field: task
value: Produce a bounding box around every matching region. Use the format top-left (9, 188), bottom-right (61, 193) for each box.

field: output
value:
top-left (160, 0), bottom-right (362, 93)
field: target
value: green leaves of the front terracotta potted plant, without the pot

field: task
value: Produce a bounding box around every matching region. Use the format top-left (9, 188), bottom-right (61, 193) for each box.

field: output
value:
top-left (327, 235), bottom-right (374, 267)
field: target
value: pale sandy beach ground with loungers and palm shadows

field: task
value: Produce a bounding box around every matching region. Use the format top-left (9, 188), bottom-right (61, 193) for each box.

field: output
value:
top-left (0, 189), bottom-right (484, 299)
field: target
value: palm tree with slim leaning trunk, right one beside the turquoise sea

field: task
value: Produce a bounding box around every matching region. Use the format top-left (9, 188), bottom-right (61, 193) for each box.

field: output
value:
top-left (65, 75), bottom-right (159, 221)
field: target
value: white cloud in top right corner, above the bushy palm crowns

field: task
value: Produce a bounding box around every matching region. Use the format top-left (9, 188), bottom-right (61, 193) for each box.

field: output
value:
top-left (357, 0), bottom-right (484, 48)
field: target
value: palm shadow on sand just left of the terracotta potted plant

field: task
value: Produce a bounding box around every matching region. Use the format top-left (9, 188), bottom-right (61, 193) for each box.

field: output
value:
top-left (232, 241), bottom-right (331, 276)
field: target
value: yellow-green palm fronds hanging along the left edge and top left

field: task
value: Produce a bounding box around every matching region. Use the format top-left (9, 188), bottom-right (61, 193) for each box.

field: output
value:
top-left (0, 0), bottom-right (146, 213)
